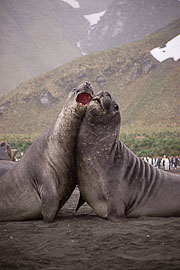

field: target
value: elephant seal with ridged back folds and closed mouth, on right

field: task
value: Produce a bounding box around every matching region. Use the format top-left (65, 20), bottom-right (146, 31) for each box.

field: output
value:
top-left (76, 92), bottom-right (180, 221)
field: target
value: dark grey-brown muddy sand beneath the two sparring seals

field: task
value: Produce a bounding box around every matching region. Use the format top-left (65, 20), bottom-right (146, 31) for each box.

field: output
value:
top-left (0, 170), bottom-right (180, 270)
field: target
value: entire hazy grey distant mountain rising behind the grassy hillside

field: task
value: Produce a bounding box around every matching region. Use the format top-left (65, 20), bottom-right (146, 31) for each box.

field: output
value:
top-left (0, 0), bottom-right (180, 95)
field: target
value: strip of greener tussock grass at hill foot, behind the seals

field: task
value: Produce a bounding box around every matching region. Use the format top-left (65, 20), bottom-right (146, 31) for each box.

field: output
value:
top-left (0, 130), bottom-right (180, 157)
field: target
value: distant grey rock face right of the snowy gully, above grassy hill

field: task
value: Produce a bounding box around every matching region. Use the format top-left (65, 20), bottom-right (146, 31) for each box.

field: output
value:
top-left (81, 0), bottom-right (180, 54)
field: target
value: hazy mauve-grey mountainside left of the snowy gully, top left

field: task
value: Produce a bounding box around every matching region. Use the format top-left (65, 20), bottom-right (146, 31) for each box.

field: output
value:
top-left (0, 0), bottom-right (88, 95)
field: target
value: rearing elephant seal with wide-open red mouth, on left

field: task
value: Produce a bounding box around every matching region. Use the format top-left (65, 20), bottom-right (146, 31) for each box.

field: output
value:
top-left (0, 82), bottom-right (93, 222)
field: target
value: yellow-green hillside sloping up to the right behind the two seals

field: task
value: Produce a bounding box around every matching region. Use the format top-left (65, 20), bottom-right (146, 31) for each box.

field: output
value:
top-left (0, 20), bottom-right (180, 139)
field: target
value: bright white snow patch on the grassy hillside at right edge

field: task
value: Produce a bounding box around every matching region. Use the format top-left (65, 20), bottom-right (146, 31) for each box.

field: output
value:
top-left (150, 35), bottom-right (180, 62)
